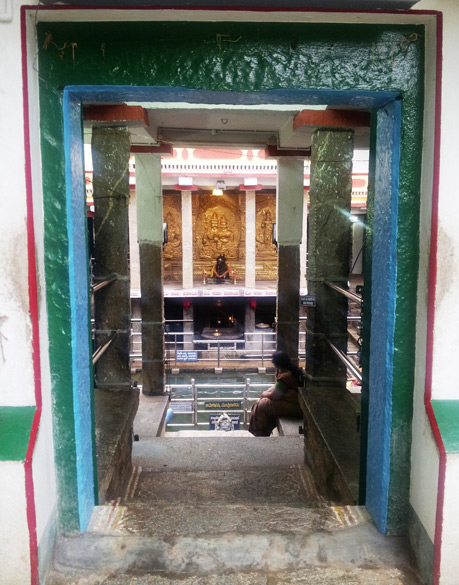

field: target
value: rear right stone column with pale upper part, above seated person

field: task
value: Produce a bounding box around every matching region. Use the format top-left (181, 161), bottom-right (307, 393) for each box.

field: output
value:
top-left (276, 159), bottom-right (304, 361)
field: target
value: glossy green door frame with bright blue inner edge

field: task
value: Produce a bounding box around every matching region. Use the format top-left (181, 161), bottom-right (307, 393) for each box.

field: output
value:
top-left (37, 16), bottom-right (424, 532)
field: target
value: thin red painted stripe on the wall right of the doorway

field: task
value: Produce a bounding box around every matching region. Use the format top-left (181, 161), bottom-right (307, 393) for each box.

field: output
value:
top-left (424, 12), bottom-right (446, 585)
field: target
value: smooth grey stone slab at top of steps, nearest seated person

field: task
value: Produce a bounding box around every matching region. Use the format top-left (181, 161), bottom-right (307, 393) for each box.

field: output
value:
top-left (132, 435), bottom-right (304, 471)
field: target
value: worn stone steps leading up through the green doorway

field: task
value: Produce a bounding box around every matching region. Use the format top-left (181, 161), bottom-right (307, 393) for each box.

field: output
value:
top-left (46, 436), bottom-right (421, 585)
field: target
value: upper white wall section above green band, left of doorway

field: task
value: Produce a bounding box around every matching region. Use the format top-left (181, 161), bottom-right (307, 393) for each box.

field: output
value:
top-left (0, 1), bottom-right (34, 406)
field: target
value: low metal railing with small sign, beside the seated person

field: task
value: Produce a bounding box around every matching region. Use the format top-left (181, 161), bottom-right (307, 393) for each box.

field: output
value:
top-left (166, 378), bottom-right (271, 429)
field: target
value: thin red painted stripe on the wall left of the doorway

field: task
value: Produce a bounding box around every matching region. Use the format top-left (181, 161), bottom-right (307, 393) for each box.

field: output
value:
top-left (21, 7), bottom-right (42, 585)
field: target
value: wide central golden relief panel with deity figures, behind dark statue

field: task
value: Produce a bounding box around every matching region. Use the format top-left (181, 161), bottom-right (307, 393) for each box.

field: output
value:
top-left (193, 194), bottom-right (245, 278)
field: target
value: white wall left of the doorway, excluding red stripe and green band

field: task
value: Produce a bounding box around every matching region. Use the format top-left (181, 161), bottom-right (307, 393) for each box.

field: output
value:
top-left (0, 0), bottom-right (56, 583)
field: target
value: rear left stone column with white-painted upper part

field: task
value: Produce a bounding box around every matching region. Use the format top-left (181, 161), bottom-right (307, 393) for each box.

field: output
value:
top-left (135, 154), bottom-right (165, 395)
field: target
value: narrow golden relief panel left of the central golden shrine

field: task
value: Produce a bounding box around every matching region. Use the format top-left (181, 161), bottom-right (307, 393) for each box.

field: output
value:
top-left (163, 195), bottom-right (182, 282)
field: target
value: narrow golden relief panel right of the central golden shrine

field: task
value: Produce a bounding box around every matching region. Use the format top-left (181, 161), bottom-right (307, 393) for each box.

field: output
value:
top-left (255, 193), bottom-right (277, 280)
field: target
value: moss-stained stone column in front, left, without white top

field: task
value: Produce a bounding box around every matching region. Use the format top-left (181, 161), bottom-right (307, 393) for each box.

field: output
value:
top-left (91, 127), bottom-right (131, 388)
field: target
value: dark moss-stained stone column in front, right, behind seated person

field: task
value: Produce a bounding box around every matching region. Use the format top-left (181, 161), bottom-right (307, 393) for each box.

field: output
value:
top-left (306, 129), bottom-right (354, 385)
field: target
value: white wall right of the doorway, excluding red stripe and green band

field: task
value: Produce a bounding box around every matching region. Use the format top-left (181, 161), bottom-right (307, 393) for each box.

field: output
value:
top-left (411, 0), bottom-right (459, 585)
